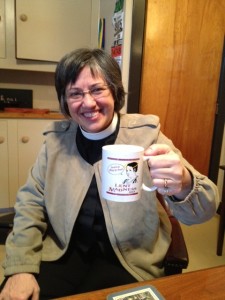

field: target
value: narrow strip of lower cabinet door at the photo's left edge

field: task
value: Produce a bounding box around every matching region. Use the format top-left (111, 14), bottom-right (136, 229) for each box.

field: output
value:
top-left (0, 121), bottom-right (9, 208)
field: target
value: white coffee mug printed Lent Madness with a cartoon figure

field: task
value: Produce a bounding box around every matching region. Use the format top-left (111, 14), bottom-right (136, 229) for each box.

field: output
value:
top-left (102, 144), bottom-right (157, 202)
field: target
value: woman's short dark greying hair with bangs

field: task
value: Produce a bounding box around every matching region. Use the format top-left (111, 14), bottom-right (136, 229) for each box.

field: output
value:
top-left (55, 48), bottom-right (125, 117)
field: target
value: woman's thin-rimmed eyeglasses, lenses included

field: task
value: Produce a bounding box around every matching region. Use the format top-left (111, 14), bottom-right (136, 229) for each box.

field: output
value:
top-left (66, 85), bottom-right (110, 103)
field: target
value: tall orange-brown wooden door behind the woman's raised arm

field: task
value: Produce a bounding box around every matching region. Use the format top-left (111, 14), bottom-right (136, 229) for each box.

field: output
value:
top-left (139, 0), bottom-right (225, 175)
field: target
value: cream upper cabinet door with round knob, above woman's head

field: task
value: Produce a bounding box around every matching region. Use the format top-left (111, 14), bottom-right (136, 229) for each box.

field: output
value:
top-left (16, 0), bottom-right (99, 62)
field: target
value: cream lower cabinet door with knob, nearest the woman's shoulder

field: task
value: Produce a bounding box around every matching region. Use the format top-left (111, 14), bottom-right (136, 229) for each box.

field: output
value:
top-left (17, 120), bottom-right (51, 186)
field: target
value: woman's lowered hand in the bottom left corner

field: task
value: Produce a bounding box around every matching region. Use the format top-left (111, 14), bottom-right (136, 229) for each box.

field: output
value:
top-left (0, 273), bottom-right (40, 300)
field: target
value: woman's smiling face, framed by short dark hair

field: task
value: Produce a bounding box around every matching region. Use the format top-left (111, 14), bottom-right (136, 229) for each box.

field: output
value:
top-left (66, 67), bottom-right (114, 133)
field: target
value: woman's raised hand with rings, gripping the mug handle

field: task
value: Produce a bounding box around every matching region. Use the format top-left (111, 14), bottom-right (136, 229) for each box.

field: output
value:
top-left (144, 144), bottom-right (192, 199)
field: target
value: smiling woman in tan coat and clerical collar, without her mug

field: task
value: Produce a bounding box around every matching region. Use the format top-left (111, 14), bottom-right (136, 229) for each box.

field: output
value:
top-left (0, 49), bottom-right (218, 300)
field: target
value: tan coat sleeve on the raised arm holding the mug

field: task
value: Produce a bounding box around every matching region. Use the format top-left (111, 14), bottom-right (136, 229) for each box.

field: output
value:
top-left (157, 133), bottom-right (219, 225)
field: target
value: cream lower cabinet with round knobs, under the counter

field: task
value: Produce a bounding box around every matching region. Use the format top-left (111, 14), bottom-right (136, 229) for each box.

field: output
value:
top-left (0, 119), bottom-right (51, 207)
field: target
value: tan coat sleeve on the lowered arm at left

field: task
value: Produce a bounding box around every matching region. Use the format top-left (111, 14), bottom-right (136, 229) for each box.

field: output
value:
top-left (3, 145), bottom-right (47, 276)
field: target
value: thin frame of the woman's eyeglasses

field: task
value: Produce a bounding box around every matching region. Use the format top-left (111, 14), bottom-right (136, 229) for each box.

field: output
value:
top-left (66, 84), bottom-right (111, 103)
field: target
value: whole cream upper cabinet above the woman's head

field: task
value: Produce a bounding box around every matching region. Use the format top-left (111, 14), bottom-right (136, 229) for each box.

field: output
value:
top-left (0, 0), bottom-right (100, 72)
